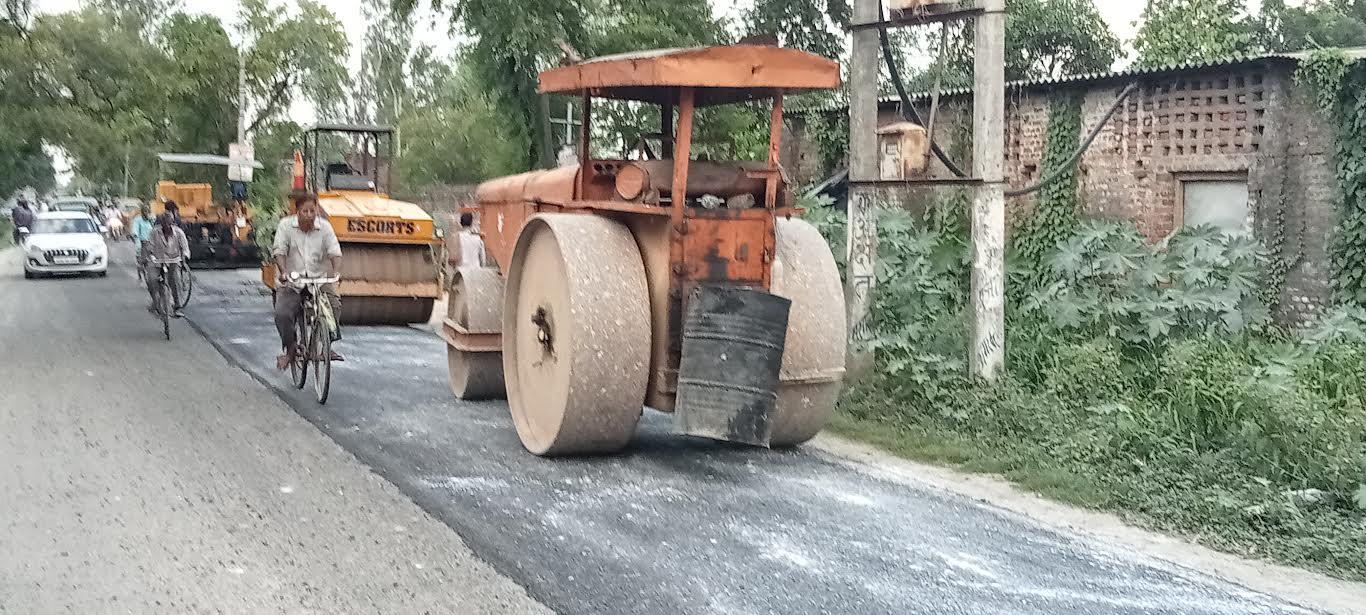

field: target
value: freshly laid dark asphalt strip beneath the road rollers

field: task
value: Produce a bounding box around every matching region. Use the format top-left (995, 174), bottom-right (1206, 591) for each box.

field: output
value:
top-left (168, 247), bottom-right (1305, 615)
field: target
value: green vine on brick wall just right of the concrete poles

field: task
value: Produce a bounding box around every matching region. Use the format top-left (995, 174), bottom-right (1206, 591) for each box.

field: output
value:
top-left (1011, 94), bottom-right (1082, 290)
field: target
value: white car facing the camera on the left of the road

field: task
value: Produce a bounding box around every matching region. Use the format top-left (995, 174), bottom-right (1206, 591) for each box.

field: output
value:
top-left (22, 212), bottom-right (109, 279)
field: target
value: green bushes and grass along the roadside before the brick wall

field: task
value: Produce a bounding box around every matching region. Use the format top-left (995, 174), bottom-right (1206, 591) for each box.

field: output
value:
top-left (811, 196), bottom-right (1366, 581)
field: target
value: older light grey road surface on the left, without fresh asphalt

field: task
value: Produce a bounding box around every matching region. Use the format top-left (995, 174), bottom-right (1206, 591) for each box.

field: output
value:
top-left (0, 244), bottom-right (549, 615)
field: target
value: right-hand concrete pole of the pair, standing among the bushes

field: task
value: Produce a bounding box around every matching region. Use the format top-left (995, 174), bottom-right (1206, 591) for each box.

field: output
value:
top-left (967, 0), bottom-right (1005, 380)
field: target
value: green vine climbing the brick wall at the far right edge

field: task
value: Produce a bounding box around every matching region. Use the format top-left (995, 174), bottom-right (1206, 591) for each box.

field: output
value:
top-left (1295, 49), bottom-right (1366, 305)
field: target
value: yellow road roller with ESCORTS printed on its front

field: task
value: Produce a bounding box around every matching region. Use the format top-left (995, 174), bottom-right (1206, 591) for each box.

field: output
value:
top-left (261, 124), bottom-right (441, 324)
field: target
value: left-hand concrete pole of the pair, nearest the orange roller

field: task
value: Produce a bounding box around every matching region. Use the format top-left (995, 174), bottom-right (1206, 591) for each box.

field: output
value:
top-left (844, 0), bottom-right (882, 352)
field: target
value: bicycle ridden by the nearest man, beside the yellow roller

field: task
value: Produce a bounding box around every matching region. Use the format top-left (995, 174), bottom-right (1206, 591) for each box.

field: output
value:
top-left (288, 272), bottom-right (340, 403)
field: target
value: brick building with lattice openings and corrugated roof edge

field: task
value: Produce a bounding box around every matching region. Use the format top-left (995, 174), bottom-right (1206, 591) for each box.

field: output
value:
top-left (784, 49), bottom-right (1366, 323)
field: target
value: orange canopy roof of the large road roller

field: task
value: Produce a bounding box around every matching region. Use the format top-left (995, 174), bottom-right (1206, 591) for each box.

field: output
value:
top-left (541, 45), bottom-right (840, 107)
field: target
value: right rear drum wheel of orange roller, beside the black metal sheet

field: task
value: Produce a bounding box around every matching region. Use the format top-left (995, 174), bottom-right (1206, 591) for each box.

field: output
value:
top-left (770, 219), bottom-right (846, 447)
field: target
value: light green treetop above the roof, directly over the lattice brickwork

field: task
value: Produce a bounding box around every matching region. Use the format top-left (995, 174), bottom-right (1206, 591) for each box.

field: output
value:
top-left (1134, 0), bottom-right (1255, 66)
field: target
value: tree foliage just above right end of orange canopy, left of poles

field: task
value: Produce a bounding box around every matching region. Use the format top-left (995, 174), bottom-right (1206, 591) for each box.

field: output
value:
top-left (744, 0), bottom-right (852, 57)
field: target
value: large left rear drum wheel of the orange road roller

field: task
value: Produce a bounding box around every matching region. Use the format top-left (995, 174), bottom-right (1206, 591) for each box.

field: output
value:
top-left (503, 213), bottom-right (650, 455)
